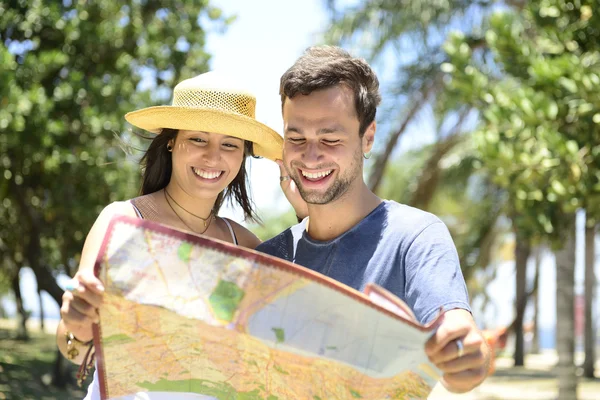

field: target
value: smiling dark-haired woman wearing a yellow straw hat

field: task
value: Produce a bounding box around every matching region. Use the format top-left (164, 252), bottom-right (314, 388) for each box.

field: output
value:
top-left (57, 72), bottom-right (305, 399)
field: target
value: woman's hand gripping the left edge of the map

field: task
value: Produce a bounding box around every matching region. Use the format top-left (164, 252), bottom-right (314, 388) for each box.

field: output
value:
top-left (60, 271), bottom-right (104, 342)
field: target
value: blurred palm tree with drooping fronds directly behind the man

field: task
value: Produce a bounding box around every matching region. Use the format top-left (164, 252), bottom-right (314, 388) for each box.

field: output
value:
top-left (325, 0), bottom-right (516, 322)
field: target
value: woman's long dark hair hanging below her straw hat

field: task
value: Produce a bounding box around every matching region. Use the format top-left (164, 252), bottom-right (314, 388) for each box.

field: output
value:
top-left (140, 128), bottom-right (259, 221)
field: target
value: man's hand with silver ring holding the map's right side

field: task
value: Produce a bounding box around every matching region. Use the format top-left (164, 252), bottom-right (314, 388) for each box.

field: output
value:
top-left (425, 309), bottom-right (490, 393)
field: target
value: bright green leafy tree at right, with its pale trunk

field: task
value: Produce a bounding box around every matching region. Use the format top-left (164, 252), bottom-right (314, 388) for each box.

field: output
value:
top-left (443, 0), bottom-right (600, 400)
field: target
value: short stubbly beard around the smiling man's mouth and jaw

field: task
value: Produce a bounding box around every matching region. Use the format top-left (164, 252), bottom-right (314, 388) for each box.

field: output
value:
top-left (290, 147), bottom-right (362, 205)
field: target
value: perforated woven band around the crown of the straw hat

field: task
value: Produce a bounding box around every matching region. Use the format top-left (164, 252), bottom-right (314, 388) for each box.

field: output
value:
top-left (173, 90), bottom-right (256, 118)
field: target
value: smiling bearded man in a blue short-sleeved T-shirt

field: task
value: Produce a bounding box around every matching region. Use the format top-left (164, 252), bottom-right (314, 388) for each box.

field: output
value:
top-left (257, 46), bottom-right (490, 392)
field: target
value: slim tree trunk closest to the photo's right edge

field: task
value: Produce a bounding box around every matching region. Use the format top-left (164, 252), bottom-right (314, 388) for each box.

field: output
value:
top-left (583, 225), bottom-right (596, 378)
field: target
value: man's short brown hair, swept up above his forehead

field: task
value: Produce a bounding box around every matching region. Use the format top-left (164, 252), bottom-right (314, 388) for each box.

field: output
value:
top-left (279, 46), bottom-right (381, 137)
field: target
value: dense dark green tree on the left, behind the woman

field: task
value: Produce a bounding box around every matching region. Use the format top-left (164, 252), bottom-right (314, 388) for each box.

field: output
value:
top-left (0, 0), bottom-right (229, 386)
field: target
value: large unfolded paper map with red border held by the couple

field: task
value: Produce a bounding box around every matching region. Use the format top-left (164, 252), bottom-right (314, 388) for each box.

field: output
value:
top-left (95, 216), bottom-right (438, 400)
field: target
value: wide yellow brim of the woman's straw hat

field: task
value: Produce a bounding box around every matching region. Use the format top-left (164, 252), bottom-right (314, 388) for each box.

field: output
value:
top-left (125, 106), bottom-right (283, 161)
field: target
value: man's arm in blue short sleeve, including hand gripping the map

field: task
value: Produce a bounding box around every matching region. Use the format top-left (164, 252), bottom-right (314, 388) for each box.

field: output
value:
top-left (406, 221), bottom-right (491, 393)
